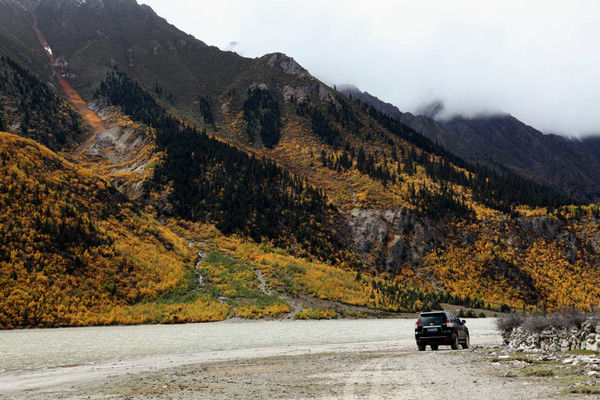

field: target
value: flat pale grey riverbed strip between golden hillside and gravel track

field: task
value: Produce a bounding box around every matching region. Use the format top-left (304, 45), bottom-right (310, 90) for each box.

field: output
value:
top-left (0, 318), bottom-right (499, 372)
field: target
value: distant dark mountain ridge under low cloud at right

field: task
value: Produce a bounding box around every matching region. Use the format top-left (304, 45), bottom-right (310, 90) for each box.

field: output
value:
top-left (340, 85), bottom-right (600, 201)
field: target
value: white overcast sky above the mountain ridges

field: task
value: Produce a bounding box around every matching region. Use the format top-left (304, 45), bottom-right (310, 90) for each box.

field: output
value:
top-left (142, 0), bottom-right (600, 135)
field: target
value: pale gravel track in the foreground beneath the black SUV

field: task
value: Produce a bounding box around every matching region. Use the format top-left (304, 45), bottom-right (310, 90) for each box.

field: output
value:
top-left (0, 321), bottom-right (562, 400)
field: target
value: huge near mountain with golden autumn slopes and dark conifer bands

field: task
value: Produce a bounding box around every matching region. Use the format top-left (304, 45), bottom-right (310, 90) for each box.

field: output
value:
top-left (0, 0), bottom-right (600, 327)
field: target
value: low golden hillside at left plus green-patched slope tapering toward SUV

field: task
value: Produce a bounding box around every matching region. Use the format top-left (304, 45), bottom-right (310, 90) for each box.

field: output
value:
top-left (0, 133), bottom-right (483, 328)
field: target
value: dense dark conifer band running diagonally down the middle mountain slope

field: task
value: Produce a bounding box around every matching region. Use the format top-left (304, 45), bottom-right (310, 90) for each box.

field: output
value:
top-left (96, 71), bottom-right (350, 261)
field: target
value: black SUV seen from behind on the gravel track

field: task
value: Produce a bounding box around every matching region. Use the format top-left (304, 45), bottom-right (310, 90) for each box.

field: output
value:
top-left (415, 311), bottom-right (469, 351)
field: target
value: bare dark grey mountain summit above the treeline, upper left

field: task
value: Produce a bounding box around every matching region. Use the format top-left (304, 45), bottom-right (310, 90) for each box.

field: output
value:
top-left (19, 0), bottom-right (252, 122)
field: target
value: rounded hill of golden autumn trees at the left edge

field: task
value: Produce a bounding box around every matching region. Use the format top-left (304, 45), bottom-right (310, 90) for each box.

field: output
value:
top-left (0, 133), bottom-right (203, 328)
